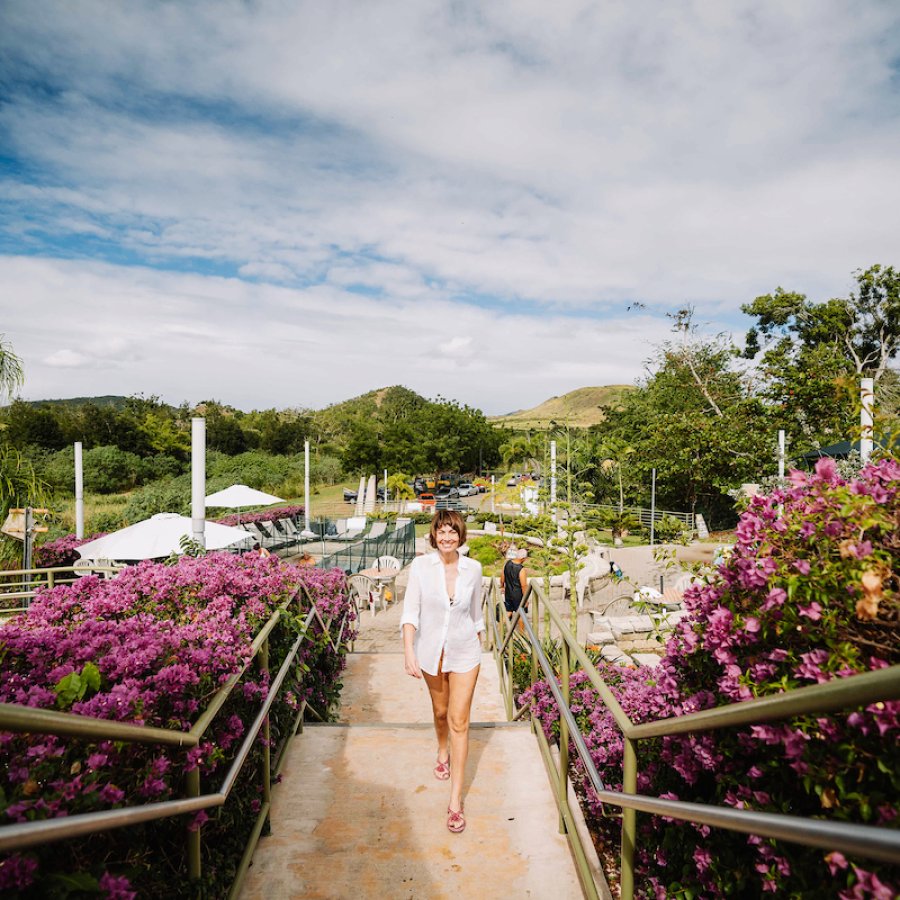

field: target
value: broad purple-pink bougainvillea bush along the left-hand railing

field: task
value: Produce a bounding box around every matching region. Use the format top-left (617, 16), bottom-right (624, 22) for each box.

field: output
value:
top-left (0, 553), bottom-right (353, 897)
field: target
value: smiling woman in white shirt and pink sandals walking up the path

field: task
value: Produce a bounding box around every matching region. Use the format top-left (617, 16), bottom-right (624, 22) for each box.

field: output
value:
top-left (400, 510), bottom-right (485, 834)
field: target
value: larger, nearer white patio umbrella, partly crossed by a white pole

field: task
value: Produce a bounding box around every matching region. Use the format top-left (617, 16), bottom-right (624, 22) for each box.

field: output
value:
top-left (77, 513), bottom-right (253, 561)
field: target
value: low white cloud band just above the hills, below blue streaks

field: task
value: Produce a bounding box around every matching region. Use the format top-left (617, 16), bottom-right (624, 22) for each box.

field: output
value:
top-left (0, 257), bottom-right (666, 414)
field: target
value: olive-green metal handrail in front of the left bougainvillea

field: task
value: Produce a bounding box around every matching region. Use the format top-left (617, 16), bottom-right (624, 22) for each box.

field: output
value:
top-left (0, 585), bottom-right (348, 896)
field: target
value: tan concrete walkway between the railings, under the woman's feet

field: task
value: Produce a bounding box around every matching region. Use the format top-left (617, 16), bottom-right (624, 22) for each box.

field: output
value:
top-left (241, 644), bottom-right (582, 900)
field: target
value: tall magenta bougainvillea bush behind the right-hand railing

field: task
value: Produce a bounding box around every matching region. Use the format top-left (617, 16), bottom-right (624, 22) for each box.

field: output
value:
top-left (530, 460), bottom-right (900, 900)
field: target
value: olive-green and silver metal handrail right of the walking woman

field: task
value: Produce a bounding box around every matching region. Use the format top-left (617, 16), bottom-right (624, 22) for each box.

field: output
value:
top-left (484, 579), bottom-right (900, 900)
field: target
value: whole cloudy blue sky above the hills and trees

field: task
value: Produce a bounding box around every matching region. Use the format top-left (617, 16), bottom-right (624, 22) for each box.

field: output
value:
top-left (0, 0), bottom-right (900, 414)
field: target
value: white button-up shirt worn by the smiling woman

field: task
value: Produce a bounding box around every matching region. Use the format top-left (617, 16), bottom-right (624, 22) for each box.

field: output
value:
top-left (400, 553), bottom-right (485, 675)
